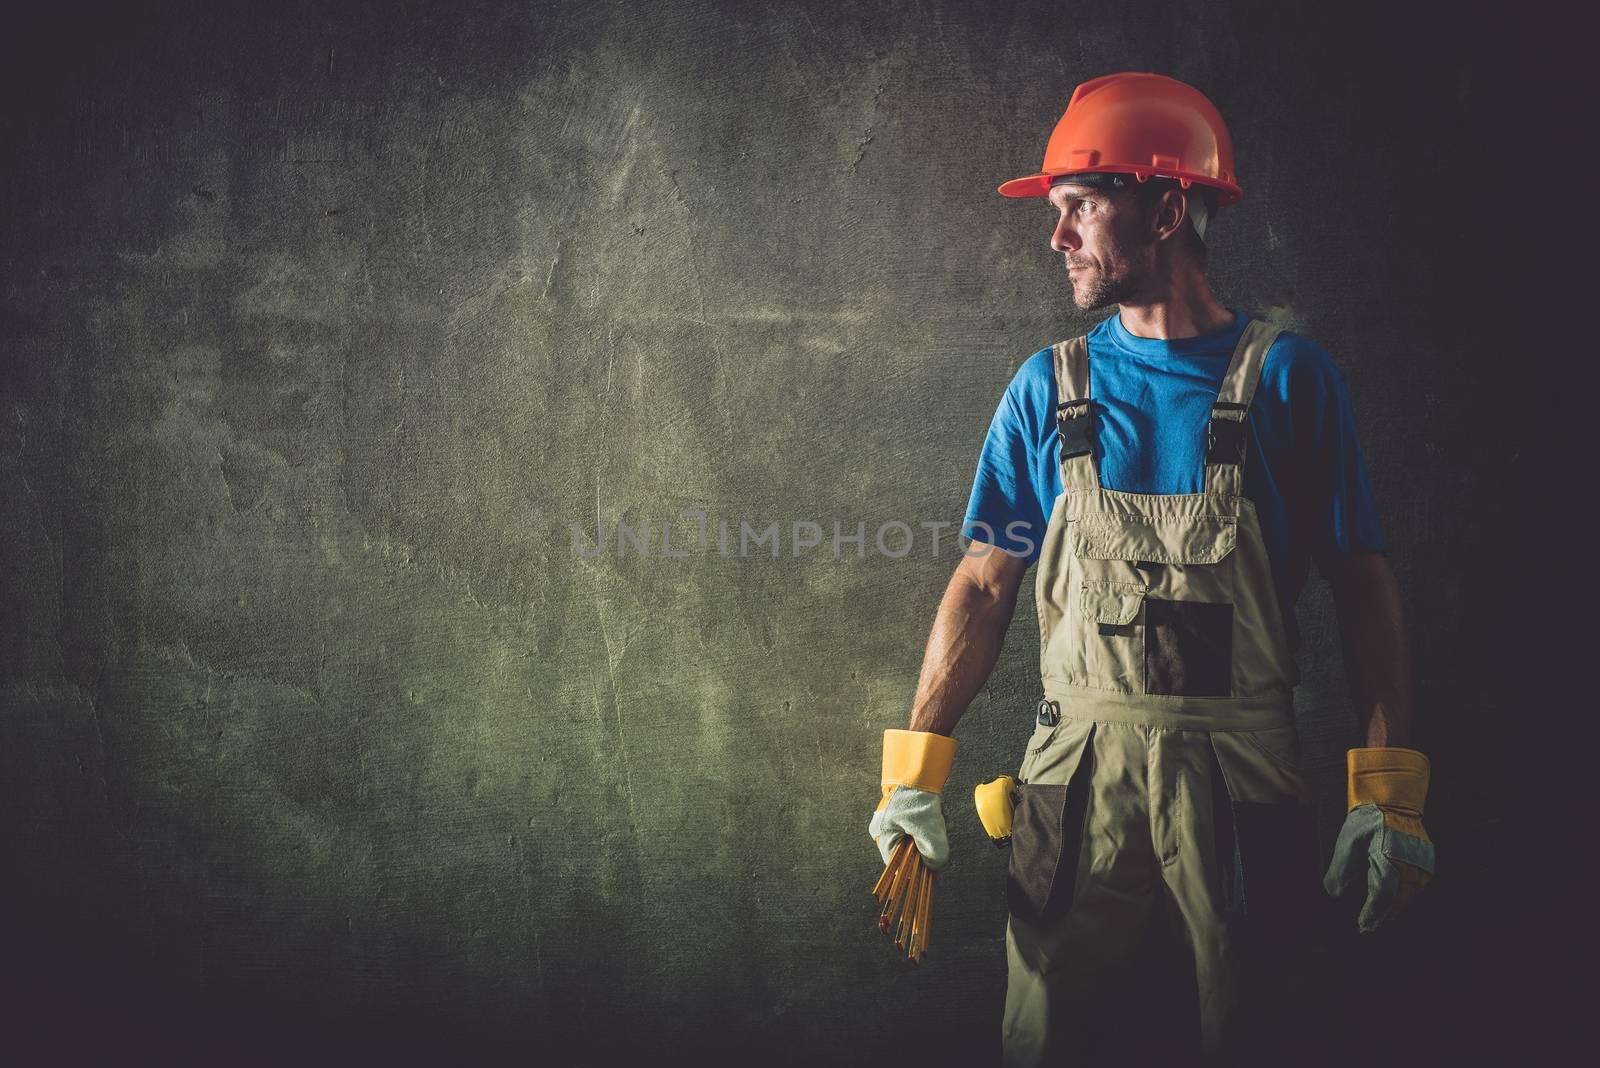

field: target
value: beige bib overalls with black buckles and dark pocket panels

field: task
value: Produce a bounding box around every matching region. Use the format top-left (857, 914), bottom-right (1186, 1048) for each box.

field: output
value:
top-left (1003, 321), bottom-right (1318, 1065)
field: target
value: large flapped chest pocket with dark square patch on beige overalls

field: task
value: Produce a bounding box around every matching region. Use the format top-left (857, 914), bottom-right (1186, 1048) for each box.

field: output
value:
top-left (1067, 513), bottom-right (1238, 697)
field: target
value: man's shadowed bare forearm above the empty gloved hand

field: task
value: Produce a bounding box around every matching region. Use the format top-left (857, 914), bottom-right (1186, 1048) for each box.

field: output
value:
top-left (1330, 553), bottom-right (1411, 747)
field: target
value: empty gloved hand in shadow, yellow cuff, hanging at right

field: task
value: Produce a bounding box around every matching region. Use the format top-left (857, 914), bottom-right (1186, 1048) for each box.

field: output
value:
top-left (1322, 747), bottom-right (1434, 934)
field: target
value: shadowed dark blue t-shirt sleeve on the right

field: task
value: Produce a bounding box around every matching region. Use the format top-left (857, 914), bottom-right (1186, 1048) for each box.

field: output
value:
top-left (1286, 336), bottom-right (1387, 577)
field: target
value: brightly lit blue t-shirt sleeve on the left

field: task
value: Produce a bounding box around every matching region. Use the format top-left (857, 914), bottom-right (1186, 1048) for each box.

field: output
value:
top-left (962, 349), bottom-right (1056, 563)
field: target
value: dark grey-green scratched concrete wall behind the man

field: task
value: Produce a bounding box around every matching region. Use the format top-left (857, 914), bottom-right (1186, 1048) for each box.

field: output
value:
top-left (0, 0), bottom-right (1548, 1063)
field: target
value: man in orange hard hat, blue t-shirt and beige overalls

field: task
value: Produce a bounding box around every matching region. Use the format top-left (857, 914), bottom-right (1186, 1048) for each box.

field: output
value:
top-left (869, 72), bottom-right (1434, 1065)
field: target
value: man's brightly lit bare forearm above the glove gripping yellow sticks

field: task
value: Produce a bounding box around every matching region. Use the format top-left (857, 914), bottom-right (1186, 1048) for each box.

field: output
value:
top-left (910, 542), bottom-right (1027, 734)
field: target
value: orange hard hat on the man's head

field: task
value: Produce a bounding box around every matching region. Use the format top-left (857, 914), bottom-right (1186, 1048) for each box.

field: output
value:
top-left (1000, 70), bottom-right (1245, 208)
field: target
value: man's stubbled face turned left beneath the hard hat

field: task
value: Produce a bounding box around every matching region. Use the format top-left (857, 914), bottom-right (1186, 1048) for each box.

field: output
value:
top-left (1050, 181), bottom-right (1155, 312)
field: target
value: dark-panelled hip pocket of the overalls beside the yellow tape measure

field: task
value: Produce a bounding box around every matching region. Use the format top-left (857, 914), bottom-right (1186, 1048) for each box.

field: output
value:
top-left (1006, 721), bottom-right (1094, 926)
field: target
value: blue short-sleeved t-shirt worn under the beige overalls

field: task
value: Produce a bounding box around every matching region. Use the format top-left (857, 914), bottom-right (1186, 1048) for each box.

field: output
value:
top-left (966, 309), bottom-right (1386, 649)
